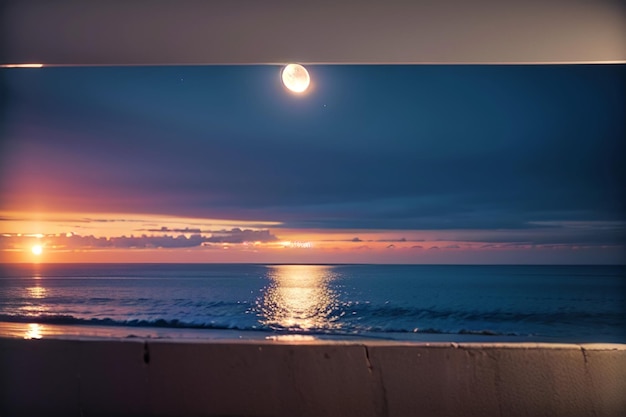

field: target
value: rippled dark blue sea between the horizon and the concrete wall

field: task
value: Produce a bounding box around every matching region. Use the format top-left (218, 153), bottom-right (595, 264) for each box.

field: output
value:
top-left (0, 264), bottom-right (626, 342)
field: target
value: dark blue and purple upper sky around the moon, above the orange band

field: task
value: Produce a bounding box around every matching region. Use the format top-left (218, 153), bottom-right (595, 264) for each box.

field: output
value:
top-left (0, 65), bottom-right (626, 255)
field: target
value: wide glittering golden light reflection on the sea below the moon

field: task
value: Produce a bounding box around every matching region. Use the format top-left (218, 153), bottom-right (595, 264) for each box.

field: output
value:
top-left (257, 265), bottom-right (340, 331)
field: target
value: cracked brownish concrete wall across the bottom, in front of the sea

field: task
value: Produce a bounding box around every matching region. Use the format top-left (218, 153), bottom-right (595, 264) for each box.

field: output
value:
top-left (0, 339), bottom-right (626, 416)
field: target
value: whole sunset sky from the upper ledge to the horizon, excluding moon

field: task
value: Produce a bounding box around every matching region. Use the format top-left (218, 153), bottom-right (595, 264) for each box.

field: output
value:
top-left (0, 64), bottom-right (626, 264)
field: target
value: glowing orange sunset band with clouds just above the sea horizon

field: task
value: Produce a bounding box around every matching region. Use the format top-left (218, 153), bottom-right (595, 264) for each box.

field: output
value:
top-left (0, 212), bottom-right (618, 263)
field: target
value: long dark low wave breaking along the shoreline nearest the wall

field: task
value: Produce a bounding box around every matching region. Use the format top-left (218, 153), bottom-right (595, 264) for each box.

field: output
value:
top-left (0, 314), bottom-right (534, 338)
